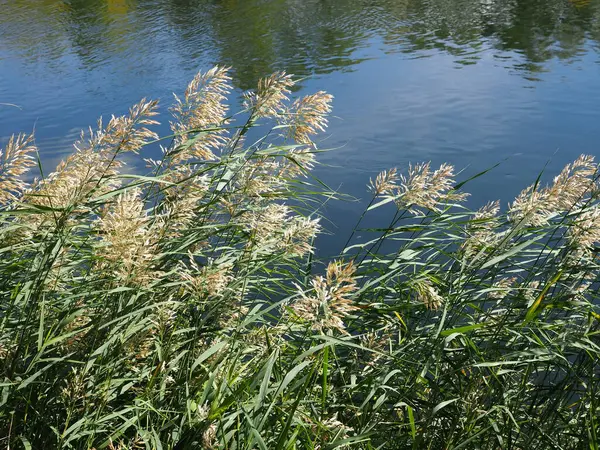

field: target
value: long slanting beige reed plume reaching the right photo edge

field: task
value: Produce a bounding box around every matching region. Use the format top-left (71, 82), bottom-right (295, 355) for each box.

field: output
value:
top-left (508, 155), bottom-right (598, 226)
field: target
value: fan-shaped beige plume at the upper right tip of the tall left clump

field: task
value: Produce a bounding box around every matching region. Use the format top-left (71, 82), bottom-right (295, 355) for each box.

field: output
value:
top-left (282, 91), bottom-right (333, 145)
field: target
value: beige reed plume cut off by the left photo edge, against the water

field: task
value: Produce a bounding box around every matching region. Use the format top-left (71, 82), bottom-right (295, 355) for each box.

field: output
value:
top-left (0, 134), bottom-right (36, 205)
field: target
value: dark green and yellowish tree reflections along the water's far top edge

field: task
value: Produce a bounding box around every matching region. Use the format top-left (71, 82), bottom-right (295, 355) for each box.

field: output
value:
top-left (0, 0), bottom-right (600, 89)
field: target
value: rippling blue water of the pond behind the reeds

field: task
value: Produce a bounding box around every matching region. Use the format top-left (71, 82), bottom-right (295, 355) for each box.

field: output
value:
top-left (0, 0), bottom-right (600, 253)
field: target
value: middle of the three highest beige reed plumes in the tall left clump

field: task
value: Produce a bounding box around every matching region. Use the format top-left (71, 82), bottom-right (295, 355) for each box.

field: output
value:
top-left (244, 72), bottom-right (295, 118)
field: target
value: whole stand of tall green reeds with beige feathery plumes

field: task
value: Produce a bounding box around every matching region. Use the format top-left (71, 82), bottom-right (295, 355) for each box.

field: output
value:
top-left (0, 67), bottom-right (600, 449)
